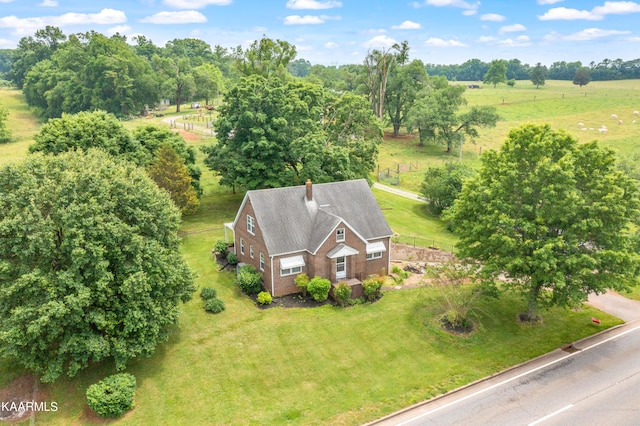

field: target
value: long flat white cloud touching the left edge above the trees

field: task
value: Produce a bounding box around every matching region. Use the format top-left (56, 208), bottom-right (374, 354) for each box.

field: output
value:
top-left (0, 9), bottom-right (127, 33)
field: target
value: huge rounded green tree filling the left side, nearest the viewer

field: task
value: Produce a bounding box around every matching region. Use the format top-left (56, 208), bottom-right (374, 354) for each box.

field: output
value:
top-left (0, 150), bottom-right (195, 382)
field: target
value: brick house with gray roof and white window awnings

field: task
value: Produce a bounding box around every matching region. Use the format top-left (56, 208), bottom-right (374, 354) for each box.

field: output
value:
top-left (230, 179), bottom-right (392, 297)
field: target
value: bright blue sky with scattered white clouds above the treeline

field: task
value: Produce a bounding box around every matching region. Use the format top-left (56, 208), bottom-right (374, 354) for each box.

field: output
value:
top-left (0, 0), bottom-right (640, 65)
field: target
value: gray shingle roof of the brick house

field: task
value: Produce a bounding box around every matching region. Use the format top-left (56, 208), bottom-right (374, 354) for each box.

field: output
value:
top-left (240, 179), bottom-right (392, 255)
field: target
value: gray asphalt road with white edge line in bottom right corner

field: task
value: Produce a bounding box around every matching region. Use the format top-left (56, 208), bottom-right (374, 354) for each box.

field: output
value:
top-left (370, 321), bottom-right (640, 426)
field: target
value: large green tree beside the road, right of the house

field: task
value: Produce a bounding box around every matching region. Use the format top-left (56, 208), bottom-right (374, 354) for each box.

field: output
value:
top-left (448, 125), bottom-right (640, 320)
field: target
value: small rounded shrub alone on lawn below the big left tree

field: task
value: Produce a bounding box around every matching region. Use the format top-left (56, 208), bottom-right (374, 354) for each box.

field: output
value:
top-left (86, 373), bottom-right (136, 417)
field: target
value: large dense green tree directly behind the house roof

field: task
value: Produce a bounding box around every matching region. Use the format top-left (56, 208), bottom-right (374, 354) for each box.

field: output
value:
top-left (204, 75), bottom-right (382, 189)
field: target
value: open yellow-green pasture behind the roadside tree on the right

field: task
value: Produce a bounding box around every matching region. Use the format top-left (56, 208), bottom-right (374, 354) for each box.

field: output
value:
top-left (378, 80), bottom-right (640, 192)
